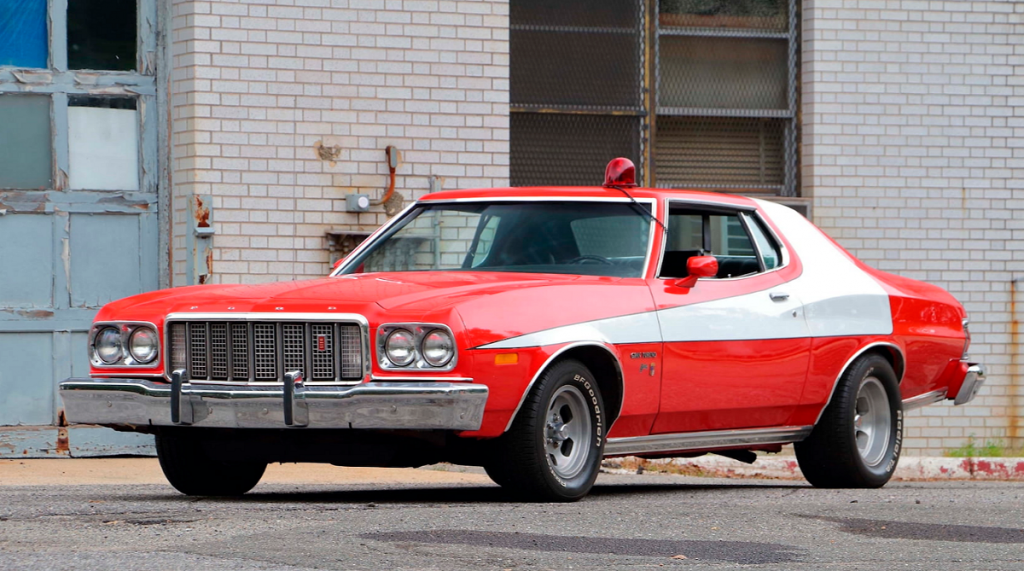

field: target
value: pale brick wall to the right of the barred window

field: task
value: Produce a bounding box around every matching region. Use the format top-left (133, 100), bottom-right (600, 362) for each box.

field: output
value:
top-left (801, 0), bottom-right (1024, 453)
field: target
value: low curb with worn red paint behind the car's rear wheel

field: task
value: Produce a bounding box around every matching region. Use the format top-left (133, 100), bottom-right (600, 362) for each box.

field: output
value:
top-left (604, 454), bottom-right (1024, 481)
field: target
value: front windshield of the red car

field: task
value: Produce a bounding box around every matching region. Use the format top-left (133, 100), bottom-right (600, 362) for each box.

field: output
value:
top-left (342, 202), bottom-right (650, 277)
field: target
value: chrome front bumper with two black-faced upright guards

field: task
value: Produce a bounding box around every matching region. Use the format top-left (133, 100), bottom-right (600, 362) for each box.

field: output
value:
top-left (60, 376), bottom-right (487, 430)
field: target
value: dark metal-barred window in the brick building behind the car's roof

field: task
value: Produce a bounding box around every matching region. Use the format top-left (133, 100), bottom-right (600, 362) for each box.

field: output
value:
top-left (510, 0), bottom-right (798, 196)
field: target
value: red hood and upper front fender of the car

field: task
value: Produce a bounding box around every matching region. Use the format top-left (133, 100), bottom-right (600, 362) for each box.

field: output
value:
top-left (96, 271), bottom-right (653, 347)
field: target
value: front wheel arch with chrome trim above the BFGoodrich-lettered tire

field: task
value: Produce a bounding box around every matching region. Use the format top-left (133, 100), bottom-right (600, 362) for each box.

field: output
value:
top-left (505, 342), bottom-right (626, 433)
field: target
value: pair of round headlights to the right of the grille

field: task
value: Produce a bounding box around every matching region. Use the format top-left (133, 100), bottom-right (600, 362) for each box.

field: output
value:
top-left (377, 323), bottom-right (457, 372)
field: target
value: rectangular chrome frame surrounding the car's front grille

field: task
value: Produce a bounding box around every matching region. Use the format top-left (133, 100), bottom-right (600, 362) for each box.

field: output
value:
top-left (157, 311), bottom-right (373, 386)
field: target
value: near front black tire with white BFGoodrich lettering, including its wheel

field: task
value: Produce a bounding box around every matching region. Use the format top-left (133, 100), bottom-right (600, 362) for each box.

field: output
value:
top-left (484, 359), bottom-right (607, 501)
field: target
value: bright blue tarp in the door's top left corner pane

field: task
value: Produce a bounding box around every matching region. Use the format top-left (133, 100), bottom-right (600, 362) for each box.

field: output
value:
top-left (0, 0), bottom-right (49, 68)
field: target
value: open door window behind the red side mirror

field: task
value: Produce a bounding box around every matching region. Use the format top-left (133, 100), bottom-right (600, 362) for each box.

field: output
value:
top-left (658, 209), bottom-right (761, 278)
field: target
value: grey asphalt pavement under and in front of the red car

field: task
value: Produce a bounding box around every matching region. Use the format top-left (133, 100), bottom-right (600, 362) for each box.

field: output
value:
top-left (0, 459), bottom-right (1024, 571)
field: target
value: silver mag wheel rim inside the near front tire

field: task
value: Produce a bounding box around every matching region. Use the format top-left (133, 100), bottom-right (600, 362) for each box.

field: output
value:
top-left (544, 385), bottom-right (594, 480)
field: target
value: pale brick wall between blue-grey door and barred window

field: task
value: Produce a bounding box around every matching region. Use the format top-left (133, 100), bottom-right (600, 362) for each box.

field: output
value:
top-left (172, 0), bottom-right (509, 286)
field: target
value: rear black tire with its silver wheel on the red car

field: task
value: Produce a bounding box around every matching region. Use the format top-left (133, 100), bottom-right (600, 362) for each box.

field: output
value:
top-left (795, 354), bottom-right (903, 488)
